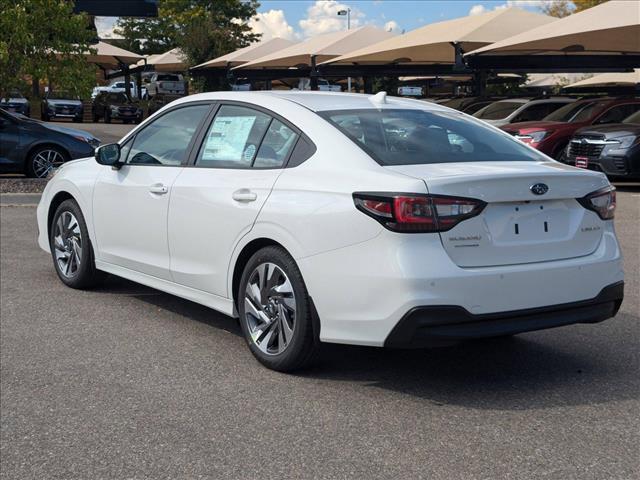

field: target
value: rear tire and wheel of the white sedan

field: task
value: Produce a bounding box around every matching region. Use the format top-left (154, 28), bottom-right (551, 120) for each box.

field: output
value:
top-left (236, 246), bottom-right (320, 372)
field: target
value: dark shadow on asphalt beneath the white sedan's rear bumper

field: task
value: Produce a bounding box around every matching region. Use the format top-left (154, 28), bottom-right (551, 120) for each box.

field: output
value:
top-left (300, 314), bottom-right (640, 411)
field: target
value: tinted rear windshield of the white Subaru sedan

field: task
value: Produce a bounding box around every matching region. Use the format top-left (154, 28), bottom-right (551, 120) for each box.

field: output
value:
top-left (318, 109), bottom-right (544, 165)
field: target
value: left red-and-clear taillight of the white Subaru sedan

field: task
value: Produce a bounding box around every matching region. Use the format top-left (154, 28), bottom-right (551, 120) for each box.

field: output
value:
top-left (353, 192), bottom-right (486, 233)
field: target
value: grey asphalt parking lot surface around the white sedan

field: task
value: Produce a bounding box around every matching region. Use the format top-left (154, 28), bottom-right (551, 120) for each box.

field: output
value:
top-left (0, 187), bottom-right (640, 479)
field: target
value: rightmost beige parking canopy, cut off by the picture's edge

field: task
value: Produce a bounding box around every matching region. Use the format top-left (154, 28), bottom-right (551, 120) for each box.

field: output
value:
top-left (469, 0), bottom-right (640, 55)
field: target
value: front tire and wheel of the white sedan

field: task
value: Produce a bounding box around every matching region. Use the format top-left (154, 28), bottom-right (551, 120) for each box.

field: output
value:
top-left (49, 199), bottom-right (105, 289)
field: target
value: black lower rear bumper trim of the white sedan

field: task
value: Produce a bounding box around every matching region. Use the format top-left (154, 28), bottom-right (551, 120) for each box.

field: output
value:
top-left (384, 282), bottom-right (624, 348)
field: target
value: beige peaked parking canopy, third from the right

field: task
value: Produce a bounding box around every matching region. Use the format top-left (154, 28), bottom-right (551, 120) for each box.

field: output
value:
top-left (236, 25), bottom-right (394, 68)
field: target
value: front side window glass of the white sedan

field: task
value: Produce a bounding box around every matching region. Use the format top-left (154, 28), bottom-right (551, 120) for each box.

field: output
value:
top-left (127, 105), bottom-right (210, 165)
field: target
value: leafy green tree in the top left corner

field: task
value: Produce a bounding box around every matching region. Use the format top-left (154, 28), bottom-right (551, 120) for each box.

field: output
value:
top-left (0, 0), bottom-right (95, 96)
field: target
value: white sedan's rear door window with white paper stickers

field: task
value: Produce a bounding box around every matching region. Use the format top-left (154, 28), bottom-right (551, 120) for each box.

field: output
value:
top-left (196, 105), bottom-right (274, 168)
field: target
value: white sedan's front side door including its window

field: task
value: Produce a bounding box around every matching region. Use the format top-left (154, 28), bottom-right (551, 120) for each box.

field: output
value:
top-left (93, 103), bottom-right (211, 280)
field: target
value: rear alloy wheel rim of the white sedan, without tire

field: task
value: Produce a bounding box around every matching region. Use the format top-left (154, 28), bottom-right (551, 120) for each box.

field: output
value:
top-left (244, 263), bottom-right (296, 355)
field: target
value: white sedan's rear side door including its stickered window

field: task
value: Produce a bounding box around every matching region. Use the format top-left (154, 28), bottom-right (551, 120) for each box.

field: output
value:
top-left (168, 104), bottom-right (300, 297)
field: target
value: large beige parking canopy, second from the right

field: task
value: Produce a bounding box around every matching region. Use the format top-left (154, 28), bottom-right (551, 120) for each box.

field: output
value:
top-left (327, 8), bottom-right (556, 65)
